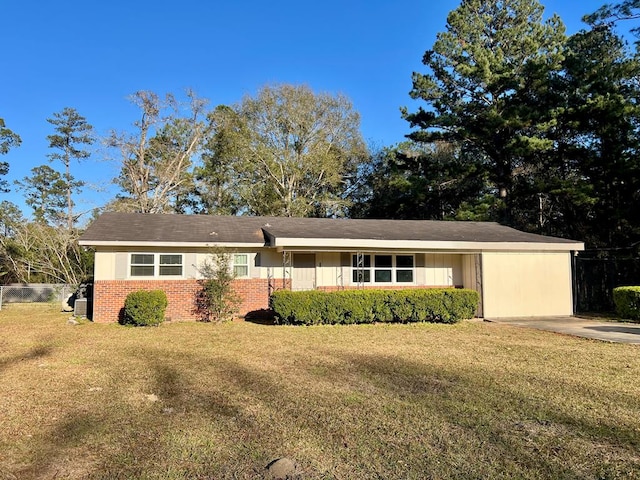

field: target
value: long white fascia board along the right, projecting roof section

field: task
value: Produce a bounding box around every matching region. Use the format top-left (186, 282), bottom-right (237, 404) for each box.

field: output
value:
top-left (272, 238), bottom-right (584, 252)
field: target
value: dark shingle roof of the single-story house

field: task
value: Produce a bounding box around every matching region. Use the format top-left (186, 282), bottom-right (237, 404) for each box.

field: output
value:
top-left (81, 213), bottom-right (578, 245)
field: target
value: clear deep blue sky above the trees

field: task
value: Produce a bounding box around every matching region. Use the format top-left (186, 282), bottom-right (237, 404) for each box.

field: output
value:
top-left (0, 0), bottom-right (616, 218)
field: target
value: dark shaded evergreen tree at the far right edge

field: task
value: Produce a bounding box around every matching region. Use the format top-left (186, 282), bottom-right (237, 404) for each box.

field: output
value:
top-left (553, 26), bottom-right (640, 247)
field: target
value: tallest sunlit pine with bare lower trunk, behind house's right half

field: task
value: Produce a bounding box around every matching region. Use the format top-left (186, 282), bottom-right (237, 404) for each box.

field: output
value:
top-left (404, 0), bottom-right (565, 223)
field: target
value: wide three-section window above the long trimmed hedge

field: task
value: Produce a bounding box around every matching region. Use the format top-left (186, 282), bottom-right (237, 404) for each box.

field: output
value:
top-left (351, 254), bottom-right (414, 284)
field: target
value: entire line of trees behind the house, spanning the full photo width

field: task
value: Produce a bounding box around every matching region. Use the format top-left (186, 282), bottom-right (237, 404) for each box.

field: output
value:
top-left (0, 0), bottom-right (640, 283)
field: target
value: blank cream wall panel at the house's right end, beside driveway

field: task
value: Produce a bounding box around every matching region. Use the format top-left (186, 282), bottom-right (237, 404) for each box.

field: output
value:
top-left (482, 252), bottom-right (573, 318)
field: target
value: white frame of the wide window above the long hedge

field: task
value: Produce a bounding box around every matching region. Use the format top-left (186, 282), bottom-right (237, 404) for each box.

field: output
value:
top-left (350, 252), bottom-right (416, 286)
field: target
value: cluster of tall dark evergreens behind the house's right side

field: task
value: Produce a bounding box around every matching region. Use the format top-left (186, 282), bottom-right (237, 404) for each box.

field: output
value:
top-left (361, 0), bottom-right (640, 248)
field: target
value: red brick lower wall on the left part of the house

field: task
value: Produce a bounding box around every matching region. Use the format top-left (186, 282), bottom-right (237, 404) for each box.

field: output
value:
top-left (93, 278), bottom-right (282, 322)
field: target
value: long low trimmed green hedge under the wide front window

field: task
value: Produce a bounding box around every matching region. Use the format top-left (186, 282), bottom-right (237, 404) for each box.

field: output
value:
top-left (271, 288), bottom-right (480, 325)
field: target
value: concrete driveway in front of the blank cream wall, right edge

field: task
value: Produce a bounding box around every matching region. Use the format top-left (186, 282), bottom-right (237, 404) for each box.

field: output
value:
top-left (485, 317), bottom-right (640, 344)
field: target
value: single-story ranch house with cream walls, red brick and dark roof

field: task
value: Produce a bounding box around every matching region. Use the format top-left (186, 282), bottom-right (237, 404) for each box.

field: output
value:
top-left (80, 213), bottom-right (584, 322)
